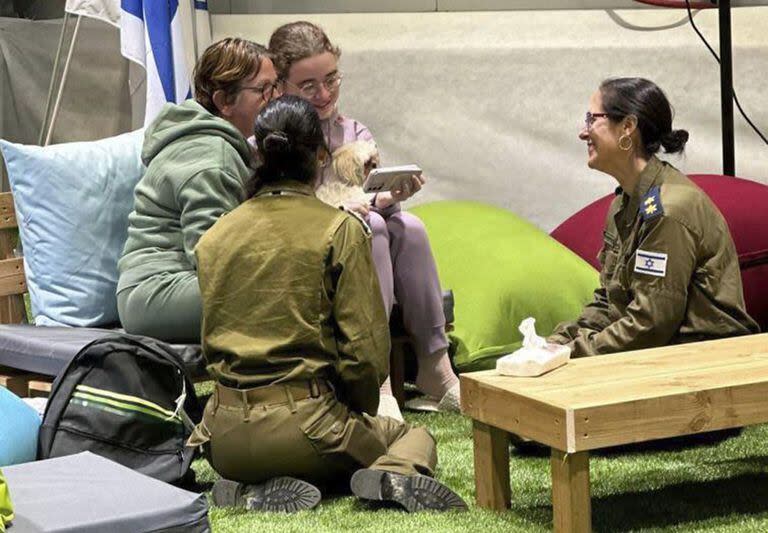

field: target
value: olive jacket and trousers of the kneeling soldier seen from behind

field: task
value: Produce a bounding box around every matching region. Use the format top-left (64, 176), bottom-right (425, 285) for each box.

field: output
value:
top-left (190, 181), bottom-right (437, 484)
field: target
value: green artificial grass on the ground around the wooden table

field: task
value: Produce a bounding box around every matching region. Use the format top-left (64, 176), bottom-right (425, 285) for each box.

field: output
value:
top-left (194, 413), bottom-right (768, 533)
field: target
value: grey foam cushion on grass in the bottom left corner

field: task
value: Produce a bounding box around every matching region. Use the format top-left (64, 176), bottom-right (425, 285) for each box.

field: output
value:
top-left (3, 452), bottom-right (210, 533)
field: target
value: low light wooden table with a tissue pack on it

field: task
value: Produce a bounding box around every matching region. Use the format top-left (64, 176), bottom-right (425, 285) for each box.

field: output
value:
top-left (461, 334), bottom-right (768, 532)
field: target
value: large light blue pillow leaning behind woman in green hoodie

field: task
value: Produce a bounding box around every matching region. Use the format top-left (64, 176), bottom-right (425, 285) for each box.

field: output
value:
top-left (0, 130), bottom-right (144, 326)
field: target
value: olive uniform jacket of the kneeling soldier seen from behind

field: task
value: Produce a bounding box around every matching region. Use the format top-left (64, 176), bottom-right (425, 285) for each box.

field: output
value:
top-left (196, 181), bottom-right (390, 414)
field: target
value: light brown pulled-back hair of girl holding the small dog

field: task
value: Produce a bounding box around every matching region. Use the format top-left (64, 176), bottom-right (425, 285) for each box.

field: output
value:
top-left (269, 20), bottom-right (341, 80)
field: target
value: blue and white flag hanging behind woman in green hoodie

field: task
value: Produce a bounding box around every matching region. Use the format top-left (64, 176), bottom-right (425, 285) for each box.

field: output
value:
top-left (120, 0), bottom-right (192, 126)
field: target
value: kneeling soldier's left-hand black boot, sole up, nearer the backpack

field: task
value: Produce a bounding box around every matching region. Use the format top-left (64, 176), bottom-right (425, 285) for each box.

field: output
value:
top-left (211, 477), bottom-right (321, 513)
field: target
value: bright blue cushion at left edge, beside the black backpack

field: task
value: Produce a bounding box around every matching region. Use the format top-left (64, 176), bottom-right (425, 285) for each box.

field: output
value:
top-left (0, 387), bottom-right (42, 466)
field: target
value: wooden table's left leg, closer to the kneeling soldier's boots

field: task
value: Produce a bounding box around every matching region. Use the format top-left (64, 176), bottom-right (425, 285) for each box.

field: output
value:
top-left (472, 420), bottom-right (511, 511)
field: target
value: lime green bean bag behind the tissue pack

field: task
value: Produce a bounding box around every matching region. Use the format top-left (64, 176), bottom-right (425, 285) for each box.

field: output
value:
top-left (411, 201), bottom-right (599, 371)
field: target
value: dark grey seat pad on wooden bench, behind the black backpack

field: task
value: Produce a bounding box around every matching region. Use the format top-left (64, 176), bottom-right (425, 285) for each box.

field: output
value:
top-left (0, 324), bottom-right (205, 377)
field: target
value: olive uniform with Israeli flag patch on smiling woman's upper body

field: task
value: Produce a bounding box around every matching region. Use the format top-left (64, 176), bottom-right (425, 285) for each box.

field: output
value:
top-left (549, 157), bottom-right (759, 356)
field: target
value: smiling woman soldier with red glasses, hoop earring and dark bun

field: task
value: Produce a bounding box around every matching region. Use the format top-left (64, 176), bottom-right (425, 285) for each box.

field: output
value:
top-left (549, 78), bottom-right (759, 356)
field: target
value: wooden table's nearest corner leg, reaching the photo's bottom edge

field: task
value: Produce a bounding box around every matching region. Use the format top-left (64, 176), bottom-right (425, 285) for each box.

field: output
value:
top-left (550, 448), bottom-right (592, 533)
